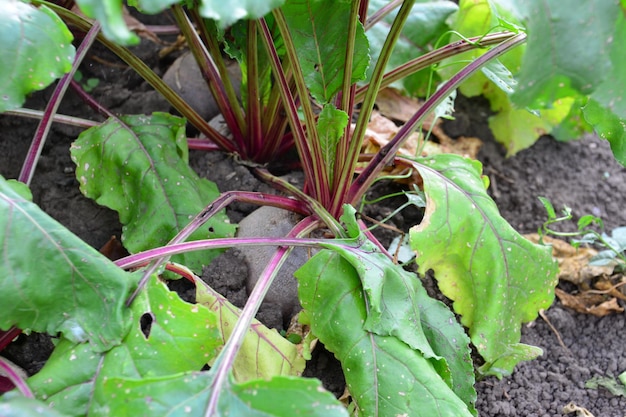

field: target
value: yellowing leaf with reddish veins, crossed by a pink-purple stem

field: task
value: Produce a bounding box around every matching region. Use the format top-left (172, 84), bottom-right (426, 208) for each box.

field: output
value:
top-left (196, 281), bottom-right (306, 382)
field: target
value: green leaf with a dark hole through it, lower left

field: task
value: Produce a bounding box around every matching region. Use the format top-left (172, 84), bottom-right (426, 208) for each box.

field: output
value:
top-left (28, 277), bottom-right (221, 415)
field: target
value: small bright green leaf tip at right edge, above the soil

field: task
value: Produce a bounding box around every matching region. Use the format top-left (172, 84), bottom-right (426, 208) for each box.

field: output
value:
top-left (583, 100), bottom-right (626, 166)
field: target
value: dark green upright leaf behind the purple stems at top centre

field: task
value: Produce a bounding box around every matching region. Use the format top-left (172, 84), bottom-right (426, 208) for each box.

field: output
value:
top-left (282, 0), bottom-right (369, 104)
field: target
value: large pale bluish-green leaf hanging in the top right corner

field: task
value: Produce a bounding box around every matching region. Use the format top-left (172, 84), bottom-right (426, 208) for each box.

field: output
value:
top-left (513, 0), bottom-right (623, 108)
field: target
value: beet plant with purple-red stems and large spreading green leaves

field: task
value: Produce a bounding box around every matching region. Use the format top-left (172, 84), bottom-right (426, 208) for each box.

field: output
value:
top-left (0, 0), bottom-right (624, 416)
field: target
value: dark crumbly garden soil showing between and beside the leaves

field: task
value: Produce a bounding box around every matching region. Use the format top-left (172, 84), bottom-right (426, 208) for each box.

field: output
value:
top-left (0, 22), bottom-right (626, 417)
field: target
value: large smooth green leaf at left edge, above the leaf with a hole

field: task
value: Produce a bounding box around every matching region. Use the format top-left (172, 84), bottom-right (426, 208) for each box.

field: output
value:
top-left (0, 176), bottom-right (135, 352)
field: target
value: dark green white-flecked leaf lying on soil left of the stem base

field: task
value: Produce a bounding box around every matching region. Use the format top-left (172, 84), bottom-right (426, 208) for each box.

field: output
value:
top-left (71, 113), bottom-right (235, 273)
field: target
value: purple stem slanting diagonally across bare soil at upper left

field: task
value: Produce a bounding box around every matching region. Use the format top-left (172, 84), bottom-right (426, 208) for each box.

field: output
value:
top-left (18, 22), bottom-right (100, 185)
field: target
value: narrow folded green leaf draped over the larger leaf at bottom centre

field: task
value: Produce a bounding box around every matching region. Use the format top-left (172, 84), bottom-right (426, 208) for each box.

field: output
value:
top-left (328, 205), bottom-right (476, 411)
